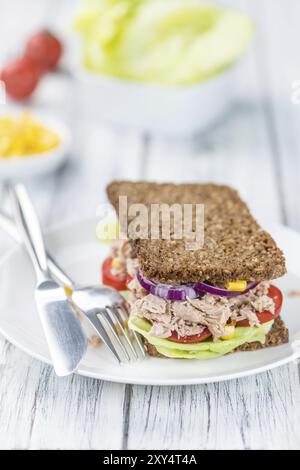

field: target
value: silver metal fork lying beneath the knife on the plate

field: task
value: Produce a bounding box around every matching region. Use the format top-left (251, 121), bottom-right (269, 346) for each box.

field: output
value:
top-left (0, 206), bottom-right (146, 363)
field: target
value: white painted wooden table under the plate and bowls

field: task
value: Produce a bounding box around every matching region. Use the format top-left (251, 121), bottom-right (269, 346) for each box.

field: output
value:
top-left (0, 0), bottom-right (300, 449)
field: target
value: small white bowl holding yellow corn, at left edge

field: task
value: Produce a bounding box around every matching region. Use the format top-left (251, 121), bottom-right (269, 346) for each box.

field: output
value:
top-left (0, 107), bottom-right (71, 181)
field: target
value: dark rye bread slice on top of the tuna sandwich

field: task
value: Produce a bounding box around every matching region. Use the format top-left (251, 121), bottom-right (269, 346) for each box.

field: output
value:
top-left (107, 181), bottom-right (286, 286)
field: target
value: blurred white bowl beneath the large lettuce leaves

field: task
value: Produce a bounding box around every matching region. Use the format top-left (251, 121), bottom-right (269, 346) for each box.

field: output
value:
top-left (76, 63), bottom-right (238, 136)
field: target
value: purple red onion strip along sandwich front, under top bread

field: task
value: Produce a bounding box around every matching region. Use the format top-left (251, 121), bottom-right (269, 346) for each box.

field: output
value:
top-left (136, 269), bottom-right (258, 301)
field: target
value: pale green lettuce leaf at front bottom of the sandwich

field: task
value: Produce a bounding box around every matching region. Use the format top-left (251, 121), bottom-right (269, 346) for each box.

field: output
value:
top-left (129, 316), bottom-right (271, 359)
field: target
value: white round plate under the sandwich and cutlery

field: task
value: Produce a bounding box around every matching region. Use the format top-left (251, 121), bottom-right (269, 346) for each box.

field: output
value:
top-left (0, 220), bottom-right (300, 385)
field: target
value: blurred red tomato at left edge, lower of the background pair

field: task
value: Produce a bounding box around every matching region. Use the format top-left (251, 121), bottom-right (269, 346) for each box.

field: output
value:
top-left (0, 57), bottom-right (40, 100)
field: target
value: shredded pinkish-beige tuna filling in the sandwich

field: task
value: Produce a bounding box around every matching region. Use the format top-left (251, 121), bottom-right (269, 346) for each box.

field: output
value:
top-left (109, 241), bottom-right (275, 341)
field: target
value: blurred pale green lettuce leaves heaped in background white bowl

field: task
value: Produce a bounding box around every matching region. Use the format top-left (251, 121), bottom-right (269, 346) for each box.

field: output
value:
top-left (74, 0), bottom-right (254, 85)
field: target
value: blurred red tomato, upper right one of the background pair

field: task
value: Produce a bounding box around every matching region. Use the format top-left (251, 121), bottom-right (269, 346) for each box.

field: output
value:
top-left (25, 31), bottom-right (63, 71)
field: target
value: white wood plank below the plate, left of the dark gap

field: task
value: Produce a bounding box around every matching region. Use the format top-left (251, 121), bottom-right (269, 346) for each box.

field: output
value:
top-left (0, 341), bottom-right (124, 449)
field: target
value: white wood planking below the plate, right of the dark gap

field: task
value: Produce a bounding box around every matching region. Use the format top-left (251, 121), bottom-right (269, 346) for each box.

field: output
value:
top-left (128, 365), bottom-right (300, 450)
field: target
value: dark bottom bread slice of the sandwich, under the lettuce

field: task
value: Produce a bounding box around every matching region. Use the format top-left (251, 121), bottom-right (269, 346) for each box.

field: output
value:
top-left (143, 317), bottom-right (289, 359)
